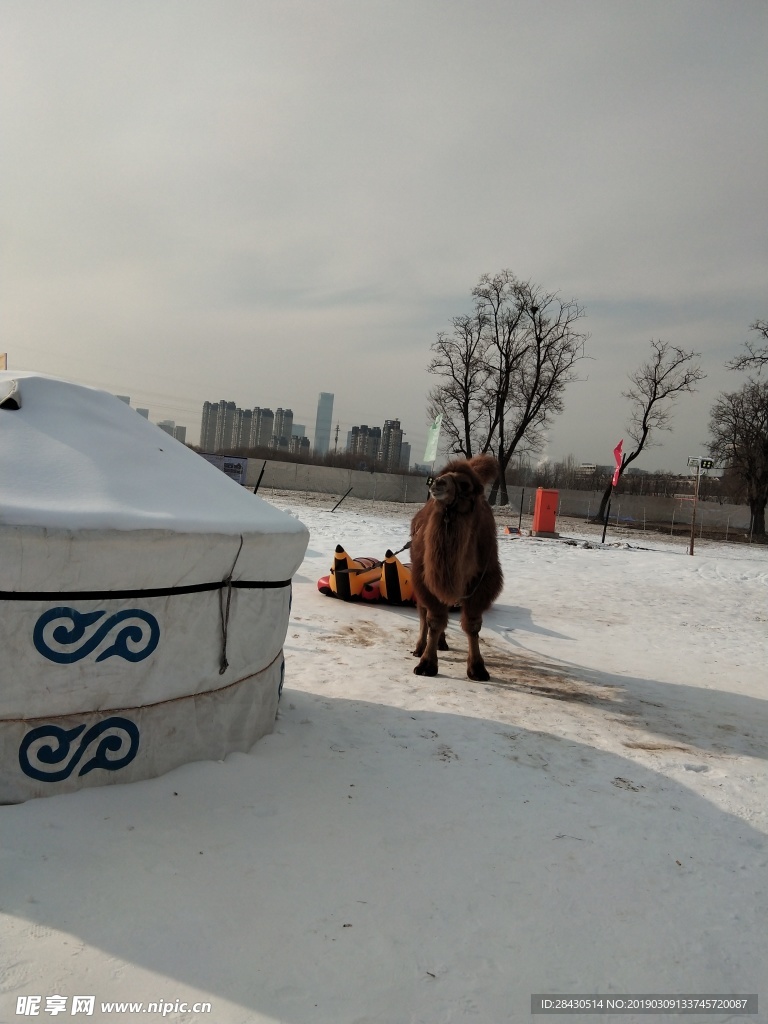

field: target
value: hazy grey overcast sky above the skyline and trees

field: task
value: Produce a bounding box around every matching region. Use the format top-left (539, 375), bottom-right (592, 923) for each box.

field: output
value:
top-left (0, 0), bottom-right (768, 471)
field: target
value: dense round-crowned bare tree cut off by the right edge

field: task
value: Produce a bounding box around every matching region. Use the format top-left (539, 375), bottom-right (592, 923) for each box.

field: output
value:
top-left (710, 379), bottom-right (768, 538)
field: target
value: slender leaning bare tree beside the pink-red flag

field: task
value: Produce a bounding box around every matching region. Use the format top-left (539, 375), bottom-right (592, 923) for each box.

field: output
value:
top-left (597, 341), bottom-right (707, 519)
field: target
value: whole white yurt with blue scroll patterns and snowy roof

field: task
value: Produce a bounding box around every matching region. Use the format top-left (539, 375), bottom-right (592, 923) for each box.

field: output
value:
top-left (0, 371), bottom-right (308, 803)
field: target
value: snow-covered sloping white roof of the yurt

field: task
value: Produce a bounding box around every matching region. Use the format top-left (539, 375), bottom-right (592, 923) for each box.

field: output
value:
top-left (0, 371), bottom-right (306, 535)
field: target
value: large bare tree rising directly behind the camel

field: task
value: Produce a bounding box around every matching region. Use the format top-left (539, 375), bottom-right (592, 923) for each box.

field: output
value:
top-left (429, 270), bottom-right (588, 504)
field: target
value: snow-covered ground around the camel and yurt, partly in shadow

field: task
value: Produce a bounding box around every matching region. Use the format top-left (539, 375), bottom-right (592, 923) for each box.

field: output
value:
top-left (0, 493), bottom-right (768, 1024)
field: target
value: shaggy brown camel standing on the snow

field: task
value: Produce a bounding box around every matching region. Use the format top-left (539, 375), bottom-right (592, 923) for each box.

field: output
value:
top-left (411, 455), bottom-right (504, 682)
